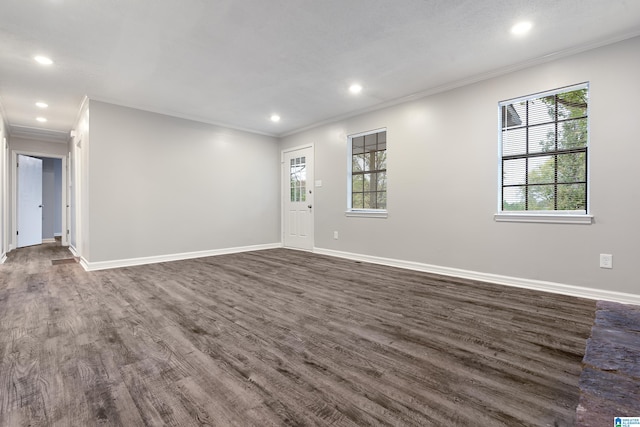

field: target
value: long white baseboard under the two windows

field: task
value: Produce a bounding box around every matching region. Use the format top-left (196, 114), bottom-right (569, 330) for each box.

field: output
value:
top-left (313, 248), bottom-right (640, 305)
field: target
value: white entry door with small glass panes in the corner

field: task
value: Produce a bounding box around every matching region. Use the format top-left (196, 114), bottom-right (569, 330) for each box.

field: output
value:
top-left (282, 147), bottom-right (314, 251)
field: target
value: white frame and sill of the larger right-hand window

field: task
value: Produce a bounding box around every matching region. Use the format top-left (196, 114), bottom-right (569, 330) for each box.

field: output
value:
top-left (494, 82), bottom-right (593, 224)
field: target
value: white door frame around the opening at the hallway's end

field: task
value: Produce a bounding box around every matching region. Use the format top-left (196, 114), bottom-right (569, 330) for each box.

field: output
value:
top-left (9, 150), bottom-right (69, 250)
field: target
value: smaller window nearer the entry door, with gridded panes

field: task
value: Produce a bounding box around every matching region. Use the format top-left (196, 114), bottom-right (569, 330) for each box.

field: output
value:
top-left (348, 129), bottom-right (387, 211)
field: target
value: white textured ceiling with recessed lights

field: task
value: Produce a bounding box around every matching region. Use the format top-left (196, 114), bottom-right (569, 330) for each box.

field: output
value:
top-left (0, 0), bottom-right (640, 139)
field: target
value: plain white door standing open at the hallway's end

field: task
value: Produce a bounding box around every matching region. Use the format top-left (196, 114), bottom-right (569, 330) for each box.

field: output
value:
top-left (17, 154), bottom-right (42, 248)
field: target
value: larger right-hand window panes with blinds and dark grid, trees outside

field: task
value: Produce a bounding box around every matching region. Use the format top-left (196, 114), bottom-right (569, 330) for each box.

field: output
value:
top-left (499, 83), bottom-right (589, 215)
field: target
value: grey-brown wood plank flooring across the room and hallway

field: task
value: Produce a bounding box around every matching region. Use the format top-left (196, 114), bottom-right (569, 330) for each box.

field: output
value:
top-left (0, 244), bottom-right (595, 426)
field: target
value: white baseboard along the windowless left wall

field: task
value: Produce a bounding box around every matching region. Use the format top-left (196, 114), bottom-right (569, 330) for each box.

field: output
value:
top-left (80, 243), bottom-right (282, 271)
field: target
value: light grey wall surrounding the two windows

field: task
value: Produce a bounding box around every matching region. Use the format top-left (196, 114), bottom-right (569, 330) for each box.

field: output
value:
top-left (280, 38), bottom-right (640, 295)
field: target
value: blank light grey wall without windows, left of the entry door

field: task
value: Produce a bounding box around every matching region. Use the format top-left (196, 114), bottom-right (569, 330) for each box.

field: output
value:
top-left (81, 100), bottom-right (280, 264)
